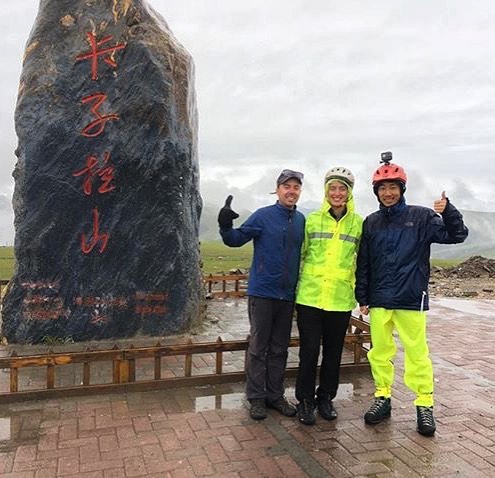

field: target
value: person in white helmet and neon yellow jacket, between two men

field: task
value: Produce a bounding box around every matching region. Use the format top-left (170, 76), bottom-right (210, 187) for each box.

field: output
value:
top-left (296, 167), bottom-right (363, 425)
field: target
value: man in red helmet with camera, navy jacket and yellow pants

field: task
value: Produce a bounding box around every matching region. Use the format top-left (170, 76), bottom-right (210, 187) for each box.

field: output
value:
top-left (356, 153), bottom-right (468, 436)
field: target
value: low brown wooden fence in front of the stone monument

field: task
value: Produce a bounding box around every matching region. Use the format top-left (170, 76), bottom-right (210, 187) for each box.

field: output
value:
top-left (0, 317), bottom-right (371, 403)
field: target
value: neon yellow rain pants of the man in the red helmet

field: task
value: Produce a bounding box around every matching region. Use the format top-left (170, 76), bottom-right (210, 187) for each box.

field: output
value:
top-left (368, 307), bottom-right (433, 407)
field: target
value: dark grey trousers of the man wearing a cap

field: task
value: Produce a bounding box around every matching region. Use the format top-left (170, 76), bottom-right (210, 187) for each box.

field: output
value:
top-left (246, 296), bottom-right (294, 402)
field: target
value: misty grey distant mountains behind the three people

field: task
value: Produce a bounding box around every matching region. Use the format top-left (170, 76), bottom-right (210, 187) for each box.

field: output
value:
top-left (199, 203), bottom-right (495, 259)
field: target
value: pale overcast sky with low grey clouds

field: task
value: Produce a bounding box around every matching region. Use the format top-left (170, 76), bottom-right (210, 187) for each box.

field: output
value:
top-left (0, 0), bottom-right (495, 245)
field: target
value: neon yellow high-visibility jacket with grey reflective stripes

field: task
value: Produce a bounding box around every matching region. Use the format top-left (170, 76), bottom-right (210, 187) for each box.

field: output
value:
top-left (296, 191), bottom-right (363, 311)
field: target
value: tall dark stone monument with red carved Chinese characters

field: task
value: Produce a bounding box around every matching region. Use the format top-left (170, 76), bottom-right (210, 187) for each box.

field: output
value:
top-left (2, 0), bottom-right (201, 343)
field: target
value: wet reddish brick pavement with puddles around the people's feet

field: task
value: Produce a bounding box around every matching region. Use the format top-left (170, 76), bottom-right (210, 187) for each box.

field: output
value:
top-left (0, 298), bottom-right (495, 478)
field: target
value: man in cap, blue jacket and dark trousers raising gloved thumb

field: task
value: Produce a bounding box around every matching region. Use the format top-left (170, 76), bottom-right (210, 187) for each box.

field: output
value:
top-left (218, 169), bottom-right (304, 420)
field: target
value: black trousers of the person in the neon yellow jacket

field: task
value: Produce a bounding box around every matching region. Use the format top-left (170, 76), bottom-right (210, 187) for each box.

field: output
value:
top-left (296, 304), bottom-right (351, 401)
